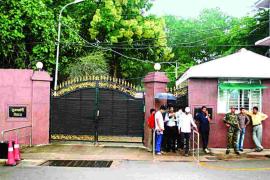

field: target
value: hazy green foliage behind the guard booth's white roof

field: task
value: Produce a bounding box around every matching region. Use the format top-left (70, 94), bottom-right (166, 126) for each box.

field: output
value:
top-left (164, 9), bottom-right (268, 86)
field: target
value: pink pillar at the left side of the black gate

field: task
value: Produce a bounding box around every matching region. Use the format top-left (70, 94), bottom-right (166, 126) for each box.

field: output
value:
top-left (31, 71), bottom-right (52, 144)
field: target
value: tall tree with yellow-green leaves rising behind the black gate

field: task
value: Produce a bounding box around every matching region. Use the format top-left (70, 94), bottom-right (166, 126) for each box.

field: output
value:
top-left (89, 0), bottom-right (173, 78)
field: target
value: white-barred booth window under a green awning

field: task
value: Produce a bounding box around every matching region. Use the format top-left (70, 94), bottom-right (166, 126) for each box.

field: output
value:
top-left (218, 80), bottom-right (266, 113)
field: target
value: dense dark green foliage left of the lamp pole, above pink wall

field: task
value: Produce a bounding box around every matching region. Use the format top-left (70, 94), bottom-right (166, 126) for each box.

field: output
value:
top-left (0, 0), bottom-right (55, 68)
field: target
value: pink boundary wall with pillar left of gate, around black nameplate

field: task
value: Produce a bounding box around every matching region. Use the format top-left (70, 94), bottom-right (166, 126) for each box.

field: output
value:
top-left (0, 69), bottom-right (52, 144)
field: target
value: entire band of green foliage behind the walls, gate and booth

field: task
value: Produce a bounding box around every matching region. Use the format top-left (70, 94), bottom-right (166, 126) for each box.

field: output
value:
top-left (0, 0), bottom-right (269, 86)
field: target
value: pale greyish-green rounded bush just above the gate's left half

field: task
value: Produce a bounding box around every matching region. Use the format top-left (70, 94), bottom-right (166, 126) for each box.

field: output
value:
top-left (68, 52), bottom-right (108, 79)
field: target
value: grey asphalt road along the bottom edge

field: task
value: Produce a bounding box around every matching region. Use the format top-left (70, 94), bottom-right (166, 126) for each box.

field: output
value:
top-left (0, 160), bottom-right (270, 180)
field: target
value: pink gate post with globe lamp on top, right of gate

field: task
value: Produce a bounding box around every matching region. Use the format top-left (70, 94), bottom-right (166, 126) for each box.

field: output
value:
top-left (143, 72), bottom-right (169, 150)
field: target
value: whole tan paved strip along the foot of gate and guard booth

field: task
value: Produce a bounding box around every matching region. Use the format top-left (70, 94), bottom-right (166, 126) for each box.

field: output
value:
top-left (17, 143), bottom-right (270, 161)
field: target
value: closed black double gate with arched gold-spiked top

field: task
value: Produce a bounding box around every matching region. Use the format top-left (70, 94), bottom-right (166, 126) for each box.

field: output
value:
top-left (50, 77), bottom-right (144, 142)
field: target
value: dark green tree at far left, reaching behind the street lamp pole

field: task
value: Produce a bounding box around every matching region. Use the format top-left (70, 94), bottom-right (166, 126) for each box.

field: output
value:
top-left (0, 0), bottom-right (85, 74)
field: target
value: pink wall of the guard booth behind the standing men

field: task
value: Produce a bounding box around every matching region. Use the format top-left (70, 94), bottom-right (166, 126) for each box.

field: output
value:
top-left (188, 79), bottom-right (270, 148)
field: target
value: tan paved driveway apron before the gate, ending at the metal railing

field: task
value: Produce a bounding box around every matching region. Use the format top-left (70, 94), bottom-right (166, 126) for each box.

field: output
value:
top-left (19, 143), bottom-right (207, 162)
